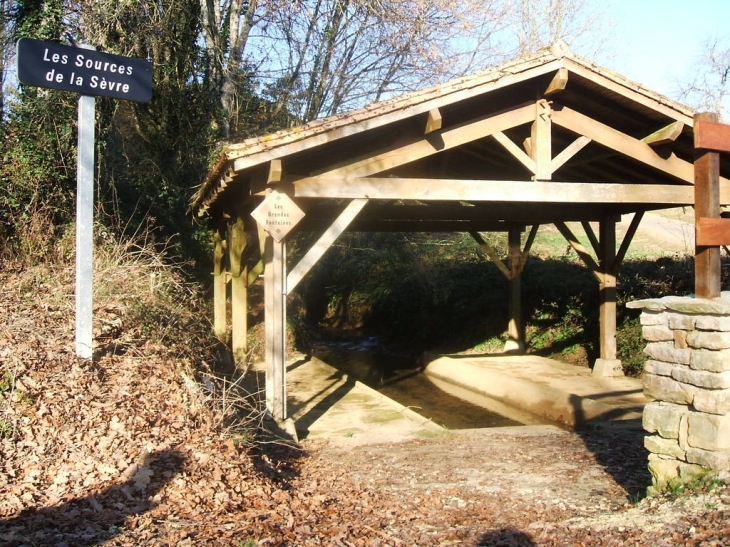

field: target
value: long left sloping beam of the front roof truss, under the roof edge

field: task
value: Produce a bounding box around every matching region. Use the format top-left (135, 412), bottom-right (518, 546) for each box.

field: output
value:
top-left (312, 105), bottom-right (535, 176)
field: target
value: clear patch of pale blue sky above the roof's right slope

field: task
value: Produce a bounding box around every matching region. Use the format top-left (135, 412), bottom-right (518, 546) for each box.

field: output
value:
top-left (592, 0), bottom-right (730, 97)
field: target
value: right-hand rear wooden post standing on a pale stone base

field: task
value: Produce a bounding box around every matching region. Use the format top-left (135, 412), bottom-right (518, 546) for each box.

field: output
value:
top-left (593, 218), bottom-right (624, 376)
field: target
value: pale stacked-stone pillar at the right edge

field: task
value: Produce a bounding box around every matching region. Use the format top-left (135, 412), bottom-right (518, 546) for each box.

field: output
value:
top-left (627, 293), bottom-right (730, 491)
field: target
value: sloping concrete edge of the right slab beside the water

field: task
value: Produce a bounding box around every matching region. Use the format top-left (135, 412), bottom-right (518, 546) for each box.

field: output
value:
top-left (424, 357), bottom-right (640, 428)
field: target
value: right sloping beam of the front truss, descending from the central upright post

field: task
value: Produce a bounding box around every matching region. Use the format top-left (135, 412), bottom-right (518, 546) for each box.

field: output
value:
top-left (552, 105), bottom-right (694, 184)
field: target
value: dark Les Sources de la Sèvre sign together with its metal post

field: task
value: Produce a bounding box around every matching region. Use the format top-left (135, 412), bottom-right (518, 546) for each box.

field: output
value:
top-left (17, 38), bottom-right (152, 359)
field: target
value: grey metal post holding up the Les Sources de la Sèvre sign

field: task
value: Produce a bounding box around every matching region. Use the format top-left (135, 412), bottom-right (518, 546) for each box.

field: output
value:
top-left (76, 45), bottom-right (96, 359)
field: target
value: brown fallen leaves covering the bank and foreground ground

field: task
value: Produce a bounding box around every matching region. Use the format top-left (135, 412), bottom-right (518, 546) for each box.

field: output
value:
top-left (0, 264), bottom-right (730, 547)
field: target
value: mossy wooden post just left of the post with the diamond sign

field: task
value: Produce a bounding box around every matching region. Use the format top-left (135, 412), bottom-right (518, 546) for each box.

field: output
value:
top-left (228, 217), bottom-right (248, 365)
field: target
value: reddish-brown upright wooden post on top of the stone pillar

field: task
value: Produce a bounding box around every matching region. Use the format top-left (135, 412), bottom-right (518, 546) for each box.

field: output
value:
top-left (694, 112), bottom-right (722, 298)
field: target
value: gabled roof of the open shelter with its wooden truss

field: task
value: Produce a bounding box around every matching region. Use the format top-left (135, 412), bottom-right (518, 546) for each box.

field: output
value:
top-left (192, 44), bottom-right (730, 231)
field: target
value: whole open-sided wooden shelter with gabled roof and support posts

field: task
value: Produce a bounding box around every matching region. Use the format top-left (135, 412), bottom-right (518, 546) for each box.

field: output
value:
top-left (193, 44), bottom-right (730, 419)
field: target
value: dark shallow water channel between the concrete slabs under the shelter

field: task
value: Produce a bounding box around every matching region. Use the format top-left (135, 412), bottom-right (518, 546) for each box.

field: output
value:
top-left (313, 338), bottom-right (545, 429)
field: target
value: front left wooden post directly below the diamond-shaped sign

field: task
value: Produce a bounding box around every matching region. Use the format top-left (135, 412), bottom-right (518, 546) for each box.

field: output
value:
top-left (264, 235), bottom-right (287, 422)
